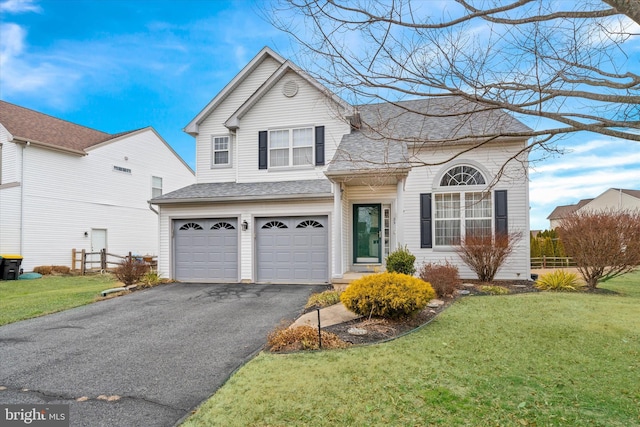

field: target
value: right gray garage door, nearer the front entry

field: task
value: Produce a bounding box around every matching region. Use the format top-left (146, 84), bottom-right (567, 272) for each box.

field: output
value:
top-left (256, 216), bottom-right (329, 283)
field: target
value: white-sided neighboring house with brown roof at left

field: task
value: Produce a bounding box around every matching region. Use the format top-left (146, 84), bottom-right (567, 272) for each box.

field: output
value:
top-left (0, 101), bottom-right (195, 271)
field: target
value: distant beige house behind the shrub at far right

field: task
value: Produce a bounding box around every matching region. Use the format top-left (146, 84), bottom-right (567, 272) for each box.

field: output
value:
top-left (547, 188), bottom-right (640, 229)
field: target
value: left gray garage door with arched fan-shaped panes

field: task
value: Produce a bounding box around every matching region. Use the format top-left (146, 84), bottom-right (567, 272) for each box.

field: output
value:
top-left (174, 218), bottom-right (238, 282)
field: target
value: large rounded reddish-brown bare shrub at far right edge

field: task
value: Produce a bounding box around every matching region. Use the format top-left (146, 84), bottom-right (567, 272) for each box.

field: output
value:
top-left (559, 210), bottom-right (640, 290)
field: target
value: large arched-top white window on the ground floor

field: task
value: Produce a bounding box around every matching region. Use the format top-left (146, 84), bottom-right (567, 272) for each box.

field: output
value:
top-left (433, 166), bottom-right (493, 246)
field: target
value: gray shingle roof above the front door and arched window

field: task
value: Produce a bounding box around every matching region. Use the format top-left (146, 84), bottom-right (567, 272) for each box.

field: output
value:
top-left (327, 96), bottom-right (531, 175)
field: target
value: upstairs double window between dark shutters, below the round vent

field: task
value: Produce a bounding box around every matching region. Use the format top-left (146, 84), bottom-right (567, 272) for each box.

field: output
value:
top-left (269, 127), bottom-right (313, 168)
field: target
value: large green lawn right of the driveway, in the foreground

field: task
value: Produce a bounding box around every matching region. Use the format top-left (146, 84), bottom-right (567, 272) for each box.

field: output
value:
top-left (184, 273), bottom-right (640, 426)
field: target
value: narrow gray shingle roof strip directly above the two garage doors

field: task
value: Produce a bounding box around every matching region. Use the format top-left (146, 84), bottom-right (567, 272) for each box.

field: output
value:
top-left (151, 179), bottom-right (333, 205)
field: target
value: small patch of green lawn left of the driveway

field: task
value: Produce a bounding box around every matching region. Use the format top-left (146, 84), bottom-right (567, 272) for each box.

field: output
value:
top-left (0, 274), bottom-right (117, 326)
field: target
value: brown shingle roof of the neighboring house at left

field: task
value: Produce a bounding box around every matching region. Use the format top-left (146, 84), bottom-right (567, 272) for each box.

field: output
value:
top-left (0, 101), bottom-right (114, 152)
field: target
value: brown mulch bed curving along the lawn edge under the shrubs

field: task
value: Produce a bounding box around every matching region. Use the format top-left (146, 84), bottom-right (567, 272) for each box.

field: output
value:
top-left (322, 280), bottom-right (538, 344)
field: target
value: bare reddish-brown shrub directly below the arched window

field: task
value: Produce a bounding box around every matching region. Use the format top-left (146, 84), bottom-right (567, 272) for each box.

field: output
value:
top-left (456, 233), bottom-right (522, 283)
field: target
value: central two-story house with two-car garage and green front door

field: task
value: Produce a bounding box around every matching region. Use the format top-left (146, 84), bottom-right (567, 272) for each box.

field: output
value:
top-left (152, 48), bottom-right (530, 283)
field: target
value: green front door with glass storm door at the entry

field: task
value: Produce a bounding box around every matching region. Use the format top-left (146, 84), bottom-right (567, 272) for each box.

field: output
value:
top-left (353, 205), bottom-right (382, 264)
